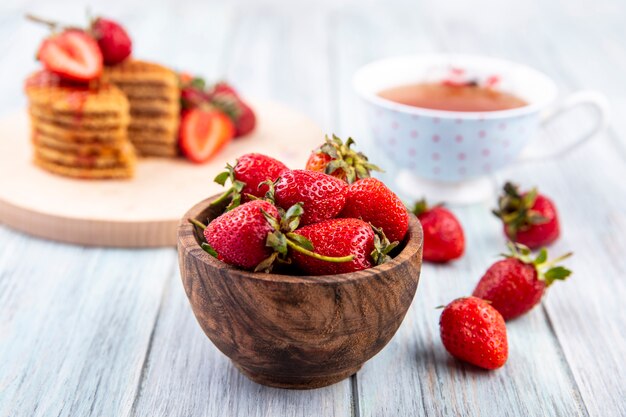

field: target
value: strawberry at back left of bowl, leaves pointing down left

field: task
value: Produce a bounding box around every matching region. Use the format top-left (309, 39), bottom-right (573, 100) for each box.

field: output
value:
top-left (212, 153), bottom-right (288, 210)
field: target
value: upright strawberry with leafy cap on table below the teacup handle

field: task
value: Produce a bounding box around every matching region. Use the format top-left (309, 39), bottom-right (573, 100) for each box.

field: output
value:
top-left (493, 182), bottom-right (560, 249)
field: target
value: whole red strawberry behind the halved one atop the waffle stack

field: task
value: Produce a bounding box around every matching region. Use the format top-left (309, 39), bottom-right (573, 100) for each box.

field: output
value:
top-left (91, 17), bottom-right (133, 65)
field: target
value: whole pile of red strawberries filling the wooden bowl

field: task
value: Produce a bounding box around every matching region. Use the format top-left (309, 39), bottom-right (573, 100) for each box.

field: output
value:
top-left (189, 136), bottom-right (409, 275)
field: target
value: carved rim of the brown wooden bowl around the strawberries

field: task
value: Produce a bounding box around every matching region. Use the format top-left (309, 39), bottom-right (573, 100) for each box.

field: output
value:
top-left (178, 194), bottom-right (424, 285)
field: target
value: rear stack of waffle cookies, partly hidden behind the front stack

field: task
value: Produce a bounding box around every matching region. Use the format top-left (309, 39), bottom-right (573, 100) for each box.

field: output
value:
top-left (103, 59), bottom-right (180, 157)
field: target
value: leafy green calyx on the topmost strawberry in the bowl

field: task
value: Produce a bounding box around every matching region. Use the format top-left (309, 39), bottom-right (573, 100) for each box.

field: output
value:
top-left (317, 134), bottom-right (383, 184)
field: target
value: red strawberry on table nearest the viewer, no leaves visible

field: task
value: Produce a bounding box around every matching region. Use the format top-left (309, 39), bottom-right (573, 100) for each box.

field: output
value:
top-left (439, 297), bottom-right (509, 369)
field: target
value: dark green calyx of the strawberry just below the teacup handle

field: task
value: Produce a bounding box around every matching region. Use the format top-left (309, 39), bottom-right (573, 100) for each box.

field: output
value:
top-left (492, 182), bottom-right (548, 240)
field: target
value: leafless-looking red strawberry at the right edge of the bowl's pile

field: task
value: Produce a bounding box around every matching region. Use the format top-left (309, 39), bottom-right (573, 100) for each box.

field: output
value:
top-left (338, 178), bottom-right (409, 242)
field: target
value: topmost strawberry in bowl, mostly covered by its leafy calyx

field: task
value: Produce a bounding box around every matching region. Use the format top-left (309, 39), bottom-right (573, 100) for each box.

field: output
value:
top-left (306, 135), bottom-right (381, 184)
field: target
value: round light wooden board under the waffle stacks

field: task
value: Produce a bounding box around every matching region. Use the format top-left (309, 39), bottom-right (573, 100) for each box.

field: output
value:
top-left (0, 102), bottom-right (323, 247)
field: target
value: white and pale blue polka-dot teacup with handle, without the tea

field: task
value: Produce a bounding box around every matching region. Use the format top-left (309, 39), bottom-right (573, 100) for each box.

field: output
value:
top-left (353, 54), bottom-right (608, 203)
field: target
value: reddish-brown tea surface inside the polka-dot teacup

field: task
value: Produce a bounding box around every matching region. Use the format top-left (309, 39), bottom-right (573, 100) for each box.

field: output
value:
top-left (378, 82), bottom-right (528, 112)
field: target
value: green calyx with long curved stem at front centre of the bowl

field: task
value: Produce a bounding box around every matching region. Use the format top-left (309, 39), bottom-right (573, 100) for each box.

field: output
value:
top-left (254, 203), bottom-right (354, 272)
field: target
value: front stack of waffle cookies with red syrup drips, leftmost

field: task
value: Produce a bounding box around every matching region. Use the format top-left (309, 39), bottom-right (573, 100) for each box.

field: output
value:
top-left (25, 72), bottom-right (136, 179)
